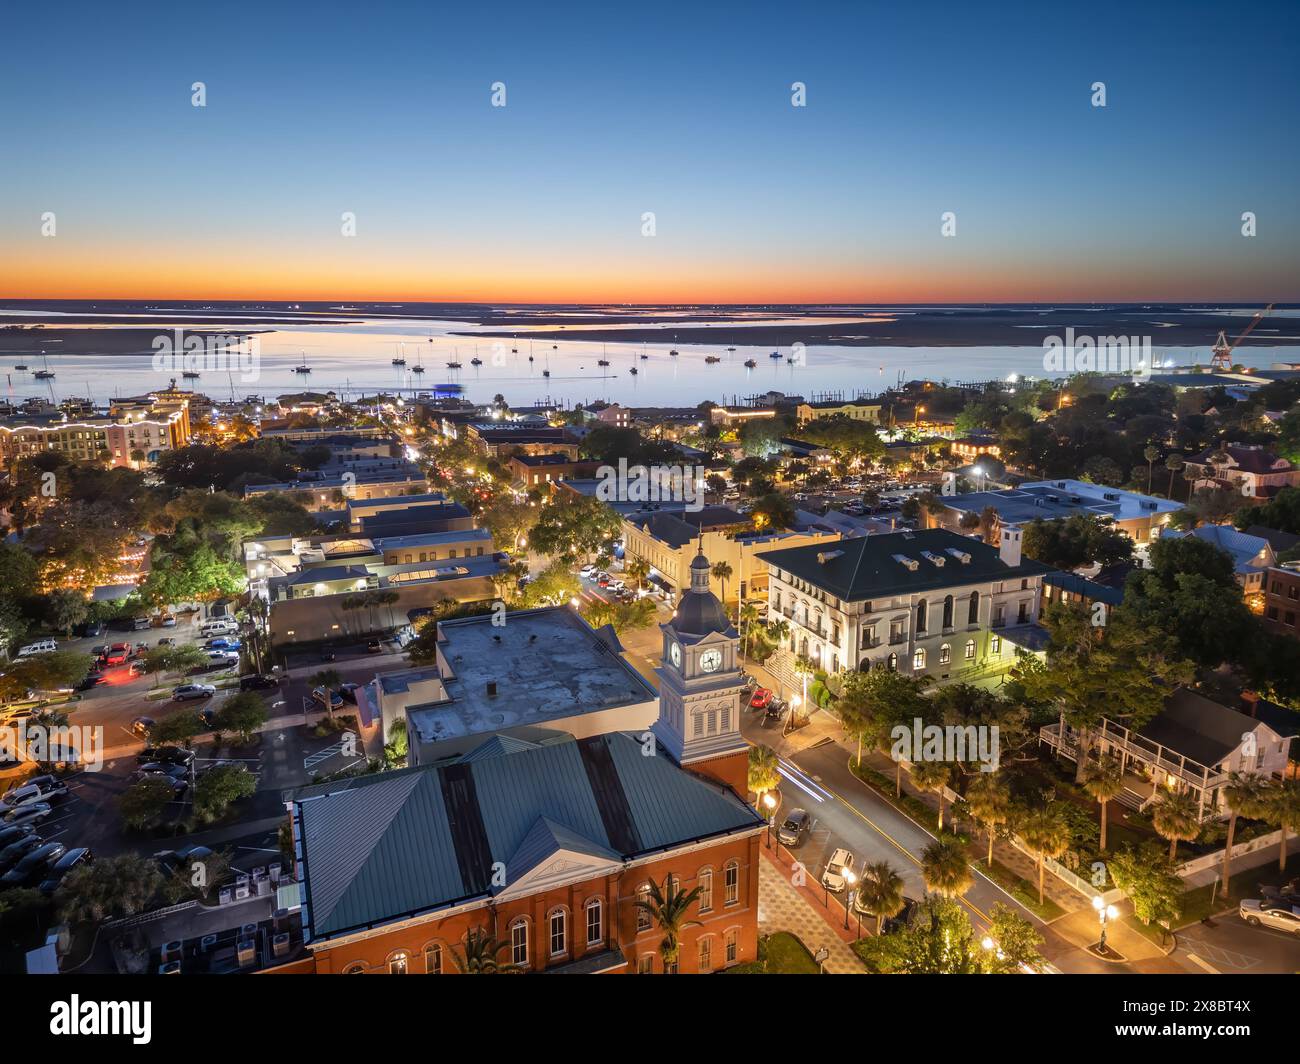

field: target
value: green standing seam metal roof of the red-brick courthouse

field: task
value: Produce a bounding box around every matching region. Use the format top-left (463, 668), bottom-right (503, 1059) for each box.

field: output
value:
top-left (295, 732), bottom-right (763, 939)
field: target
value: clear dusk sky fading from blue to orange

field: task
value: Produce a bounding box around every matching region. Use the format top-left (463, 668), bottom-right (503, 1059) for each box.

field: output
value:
top-left (0, 0), bottom-right (1300, 304)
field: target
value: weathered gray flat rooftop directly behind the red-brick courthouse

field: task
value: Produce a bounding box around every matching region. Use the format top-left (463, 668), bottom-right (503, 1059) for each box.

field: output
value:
top-left (407, 606), bottom-right (658, 743)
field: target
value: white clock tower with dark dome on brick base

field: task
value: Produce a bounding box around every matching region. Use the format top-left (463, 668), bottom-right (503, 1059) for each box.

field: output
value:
top-left (651, 552), bottom-right (749, 797)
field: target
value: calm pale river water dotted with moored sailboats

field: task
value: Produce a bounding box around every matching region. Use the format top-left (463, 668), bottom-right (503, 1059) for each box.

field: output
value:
top-left (0, 315), bottom-right (1300, 406)
